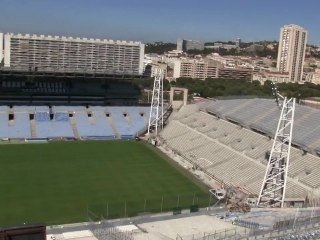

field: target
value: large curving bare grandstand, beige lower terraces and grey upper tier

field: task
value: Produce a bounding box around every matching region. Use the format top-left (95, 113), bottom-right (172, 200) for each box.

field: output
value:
top-left (160, 99), bottom-right (320, 206)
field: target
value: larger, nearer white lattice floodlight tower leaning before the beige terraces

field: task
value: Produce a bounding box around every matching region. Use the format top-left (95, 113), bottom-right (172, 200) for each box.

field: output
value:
top-left (257, 85), bottom-right (296, 207)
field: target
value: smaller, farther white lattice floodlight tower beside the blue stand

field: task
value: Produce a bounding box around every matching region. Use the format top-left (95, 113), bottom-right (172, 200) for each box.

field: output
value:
top-left (148, 68), bottom-right (163, 136)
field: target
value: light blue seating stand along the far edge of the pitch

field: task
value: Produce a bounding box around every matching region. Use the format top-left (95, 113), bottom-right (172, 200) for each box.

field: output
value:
top-left (0, 106), bottom-right (150, 141)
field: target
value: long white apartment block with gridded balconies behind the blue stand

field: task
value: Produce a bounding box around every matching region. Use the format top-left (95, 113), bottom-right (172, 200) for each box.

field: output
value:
top-left (0, 33), bottom-right (144, 75)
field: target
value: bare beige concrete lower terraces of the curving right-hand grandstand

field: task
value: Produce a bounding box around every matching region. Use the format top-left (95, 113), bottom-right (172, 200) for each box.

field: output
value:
top-left (160, 103), bottom-right (320, 198)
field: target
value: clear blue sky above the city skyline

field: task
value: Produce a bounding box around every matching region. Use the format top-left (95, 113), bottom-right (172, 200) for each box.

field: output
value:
top-left (0, 0), bottom-right (320, 44)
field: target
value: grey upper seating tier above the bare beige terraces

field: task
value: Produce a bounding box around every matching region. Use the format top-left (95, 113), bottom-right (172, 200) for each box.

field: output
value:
top-left (202, 98), bottom-right (320, 151)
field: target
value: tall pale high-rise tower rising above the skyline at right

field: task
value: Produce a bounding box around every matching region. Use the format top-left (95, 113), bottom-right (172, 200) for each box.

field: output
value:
top-left (277, 24), bottom-right (307, 82)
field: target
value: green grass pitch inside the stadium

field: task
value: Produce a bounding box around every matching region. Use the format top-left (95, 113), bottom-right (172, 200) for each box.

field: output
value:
top-left (0, 141), bottom-right (210, 226)
